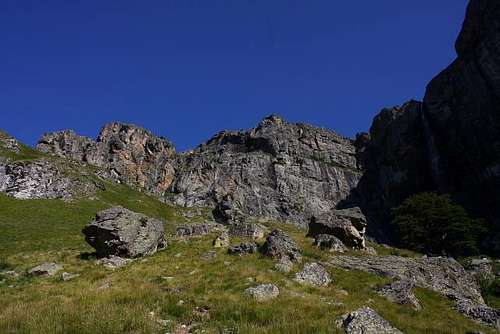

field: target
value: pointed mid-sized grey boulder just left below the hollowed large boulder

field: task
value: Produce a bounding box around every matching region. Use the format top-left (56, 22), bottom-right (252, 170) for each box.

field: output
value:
top-left (262, 229), bottom-right (302, 262)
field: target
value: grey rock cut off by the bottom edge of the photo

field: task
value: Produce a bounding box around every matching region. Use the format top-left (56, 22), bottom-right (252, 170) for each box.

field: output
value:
top-left (338, 307), bottom-right (403, 334)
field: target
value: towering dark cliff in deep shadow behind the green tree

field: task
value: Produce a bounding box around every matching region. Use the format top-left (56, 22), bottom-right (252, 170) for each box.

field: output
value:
top-left (353, 0), bottom-right (500, 248)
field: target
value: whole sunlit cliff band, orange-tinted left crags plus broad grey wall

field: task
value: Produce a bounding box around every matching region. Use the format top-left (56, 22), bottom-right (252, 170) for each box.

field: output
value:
top-left (37, 116), bottom-right (361, 226)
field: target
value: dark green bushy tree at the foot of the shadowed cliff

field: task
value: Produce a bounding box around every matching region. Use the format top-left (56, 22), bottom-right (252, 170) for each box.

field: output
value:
top-left (392, 193), bottom-right (486, 256)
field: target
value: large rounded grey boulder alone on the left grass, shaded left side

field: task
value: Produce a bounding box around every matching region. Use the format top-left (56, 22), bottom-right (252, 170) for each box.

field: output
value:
top-left (82, 207), bottom-right (166, 258)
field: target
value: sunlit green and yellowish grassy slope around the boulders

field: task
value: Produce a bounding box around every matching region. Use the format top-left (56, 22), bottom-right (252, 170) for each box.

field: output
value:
top-left (0, 145), bottom-right (494, 334)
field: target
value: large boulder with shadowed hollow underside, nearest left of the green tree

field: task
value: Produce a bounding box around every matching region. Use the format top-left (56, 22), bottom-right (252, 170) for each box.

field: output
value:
top-left (307, 207), bottom-right (367, 249)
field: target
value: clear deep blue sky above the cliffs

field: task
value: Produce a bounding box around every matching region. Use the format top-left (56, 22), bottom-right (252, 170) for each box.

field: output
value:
top-left (0, 0), bottom-right (467, 150)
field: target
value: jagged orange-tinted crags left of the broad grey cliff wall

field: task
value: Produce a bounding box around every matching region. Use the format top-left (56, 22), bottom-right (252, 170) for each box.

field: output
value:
top-left (37, 123), bottom-right (175, 194)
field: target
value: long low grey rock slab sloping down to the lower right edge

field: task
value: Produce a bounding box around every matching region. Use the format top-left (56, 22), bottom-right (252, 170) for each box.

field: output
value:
top-left (330, 256), bottom-right (499, 325)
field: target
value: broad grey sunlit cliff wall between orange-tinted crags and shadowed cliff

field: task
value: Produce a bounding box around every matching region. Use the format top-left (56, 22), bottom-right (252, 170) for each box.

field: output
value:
top-left (169, 116), bottom-right (360, 226)
